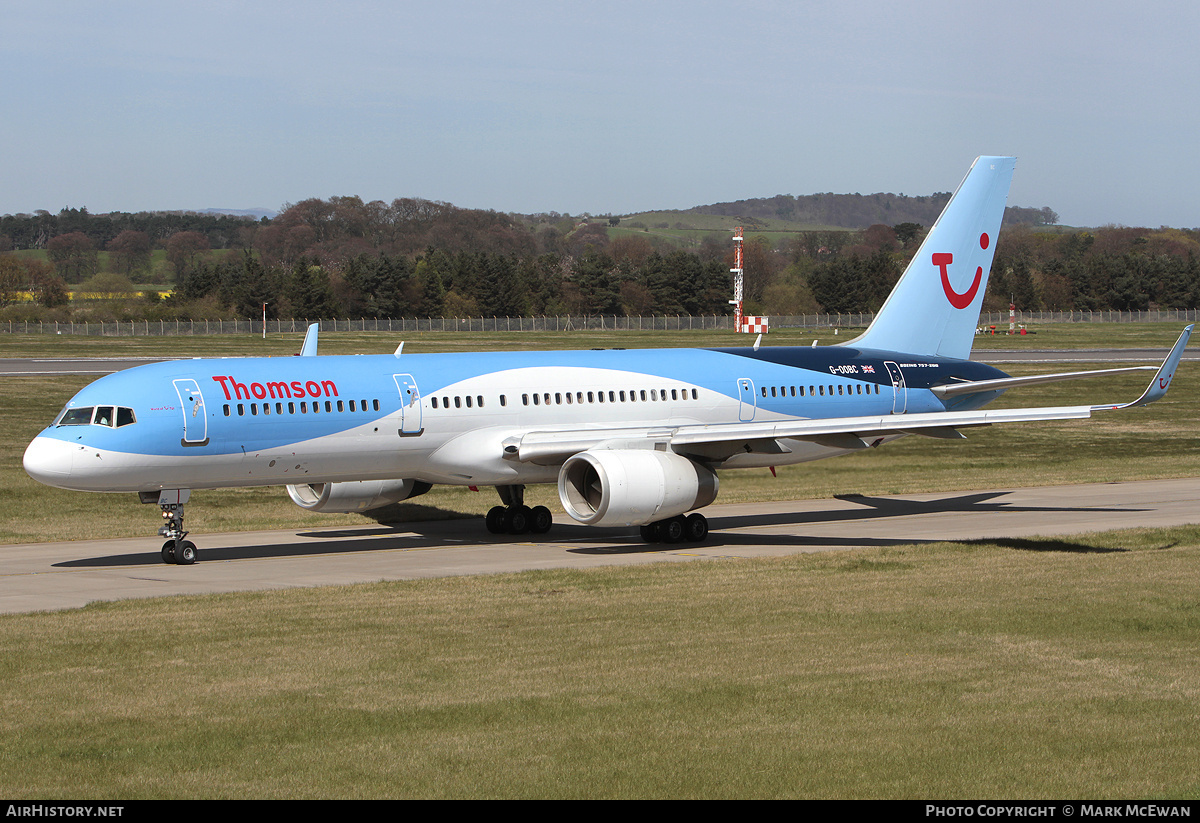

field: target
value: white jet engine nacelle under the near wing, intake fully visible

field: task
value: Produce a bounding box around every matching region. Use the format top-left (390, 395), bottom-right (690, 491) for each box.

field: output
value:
top-left (558, 449), bottom-right (720, 525)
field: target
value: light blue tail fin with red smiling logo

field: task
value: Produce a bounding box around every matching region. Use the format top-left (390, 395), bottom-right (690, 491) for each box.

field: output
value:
top-left (845, 157), bottom-right (1016, 360)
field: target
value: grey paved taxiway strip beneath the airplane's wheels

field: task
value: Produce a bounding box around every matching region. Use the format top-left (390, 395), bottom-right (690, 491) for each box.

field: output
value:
top-left (0, 477), bottom-right (1200, 613)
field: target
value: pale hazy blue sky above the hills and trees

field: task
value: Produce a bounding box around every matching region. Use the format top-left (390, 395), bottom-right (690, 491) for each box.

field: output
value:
top-left (0, 0), bottom-right (1200, 228)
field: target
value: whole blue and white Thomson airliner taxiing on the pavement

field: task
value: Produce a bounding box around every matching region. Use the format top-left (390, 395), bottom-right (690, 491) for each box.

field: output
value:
top-left (24, 156), bottom-right (1193, 565)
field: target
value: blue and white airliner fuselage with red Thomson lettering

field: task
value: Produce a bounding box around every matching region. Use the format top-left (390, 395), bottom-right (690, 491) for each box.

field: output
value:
top-left (25, 347), bottom-right (1003, 492)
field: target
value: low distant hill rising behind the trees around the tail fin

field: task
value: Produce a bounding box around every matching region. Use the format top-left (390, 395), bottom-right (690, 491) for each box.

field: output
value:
top-left (679, 192), bottom-right (1058, 229)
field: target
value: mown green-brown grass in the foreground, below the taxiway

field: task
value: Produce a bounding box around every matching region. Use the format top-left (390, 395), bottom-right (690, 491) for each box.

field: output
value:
top-left (0, 527), bottom-right (1200, 799)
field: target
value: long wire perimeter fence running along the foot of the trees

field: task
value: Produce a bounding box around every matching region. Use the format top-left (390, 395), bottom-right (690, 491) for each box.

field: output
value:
top-left (0, 308), bottom-right (1200, 337)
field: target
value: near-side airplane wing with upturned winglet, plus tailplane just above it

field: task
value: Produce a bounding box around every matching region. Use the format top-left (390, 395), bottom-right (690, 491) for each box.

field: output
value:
top-left (503, 325), bottom-right (1194, 465)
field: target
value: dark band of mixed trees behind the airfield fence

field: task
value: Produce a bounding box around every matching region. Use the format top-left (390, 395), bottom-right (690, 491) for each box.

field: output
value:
top-left (0, 197), bottom-right (1200, 319)
